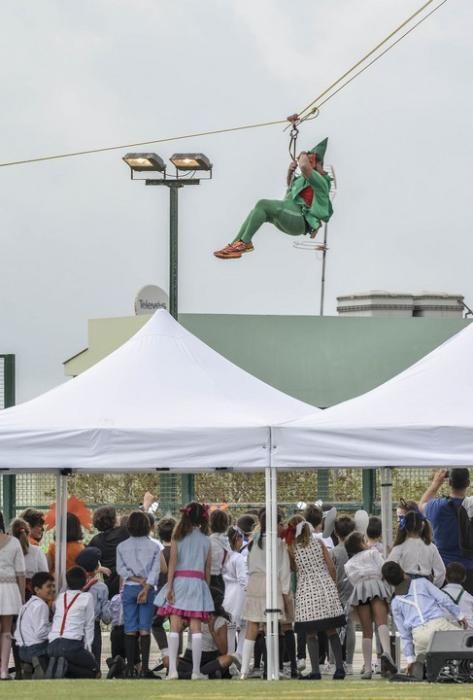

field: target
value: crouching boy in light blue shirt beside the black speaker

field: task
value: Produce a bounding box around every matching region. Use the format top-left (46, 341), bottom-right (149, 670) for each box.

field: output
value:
top-left (381, 561), bottom-right (467, 673)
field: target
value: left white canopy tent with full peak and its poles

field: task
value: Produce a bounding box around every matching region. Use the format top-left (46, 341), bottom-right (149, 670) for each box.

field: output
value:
top-left (0, 311), bottom-right (317, 679)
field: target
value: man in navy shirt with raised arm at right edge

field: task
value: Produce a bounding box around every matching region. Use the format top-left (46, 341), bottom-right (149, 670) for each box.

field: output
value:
top-left (419, 468), bottom-right (473, 595)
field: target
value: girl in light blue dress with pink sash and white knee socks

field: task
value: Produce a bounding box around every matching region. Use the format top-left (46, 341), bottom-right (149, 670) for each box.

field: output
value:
top-left (155, 502), bottom-right (214, 680)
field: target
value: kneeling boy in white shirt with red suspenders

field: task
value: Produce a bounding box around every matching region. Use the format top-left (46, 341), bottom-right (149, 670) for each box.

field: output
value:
top-left (46, 566), bottom-right (98, 678)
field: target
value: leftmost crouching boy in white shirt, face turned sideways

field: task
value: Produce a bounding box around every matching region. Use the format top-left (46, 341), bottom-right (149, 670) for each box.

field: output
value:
top-left (15, 571), bottom-right (55, 680)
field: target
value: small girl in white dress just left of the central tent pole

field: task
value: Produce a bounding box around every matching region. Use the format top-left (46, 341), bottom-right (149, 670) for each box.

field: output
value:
top-left (223, 527), bottom-right (248, 659)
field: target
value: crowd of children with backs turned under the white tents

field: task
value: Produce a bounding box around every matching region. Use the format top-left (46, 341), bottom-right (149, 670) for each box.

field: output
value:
top-left (0, 468), bottom-right (473, 681)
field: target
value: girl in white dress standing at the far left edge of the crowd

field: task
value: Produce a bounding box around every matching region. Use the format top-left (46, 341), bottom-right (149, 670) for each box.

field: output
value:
top-left (0, 533), bottom-right (25, 681)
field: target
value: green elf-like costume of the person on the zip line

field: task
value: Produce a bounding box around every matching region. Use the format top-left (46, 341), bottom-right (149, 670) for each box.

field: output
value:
top-left (233, 139), bottom-right (333, 243)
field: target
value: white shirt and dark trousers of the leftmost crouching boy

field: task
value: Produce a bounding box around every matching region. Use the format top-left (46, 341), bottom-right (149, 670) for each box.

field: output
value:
top-left (14, 595), bottom-right (51, 668)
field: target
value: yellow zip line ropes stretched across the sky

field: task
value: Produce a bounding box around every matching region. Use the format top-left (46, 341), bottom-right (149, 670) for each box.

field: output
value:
top-left (0, 0), bottom-right (447, 168)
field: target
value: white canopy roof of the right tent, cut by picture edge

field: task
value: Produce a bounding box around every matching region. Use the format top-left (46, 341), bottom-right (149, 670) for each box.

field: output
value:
top-left (273, 325), bottom-right (473, 467)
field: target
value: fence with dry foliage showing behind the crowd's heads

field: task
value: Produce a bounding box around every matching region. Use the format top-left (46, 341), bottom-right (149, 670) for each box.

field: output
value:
top-left (0, 468), bottom-right (442, 532)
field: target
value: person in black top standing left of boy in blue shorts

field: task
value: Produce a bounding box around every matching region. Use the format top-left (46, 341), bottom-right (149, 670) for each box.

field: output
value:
top-left (89, 506), bottom-right (130, 598)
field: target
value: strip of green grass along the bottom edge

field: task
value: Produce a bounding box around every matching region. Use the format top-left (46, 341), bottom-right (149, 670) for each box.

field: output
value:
top-left (0, 680), bottom-right (473, 700)
